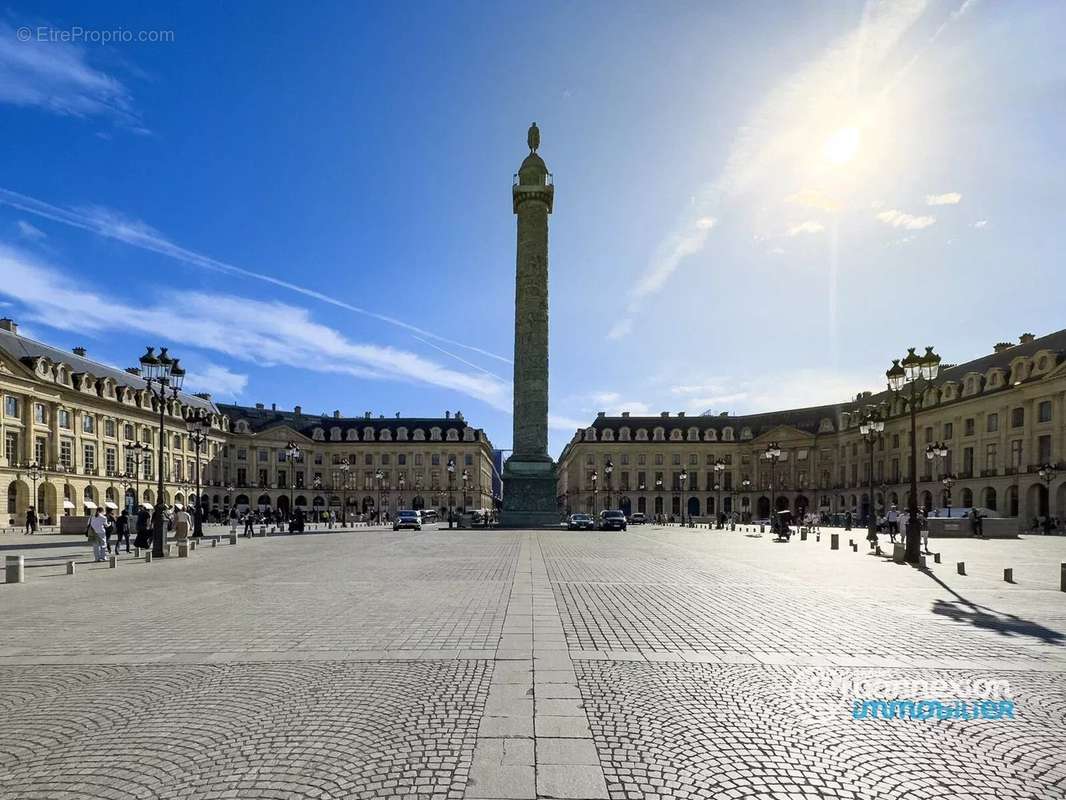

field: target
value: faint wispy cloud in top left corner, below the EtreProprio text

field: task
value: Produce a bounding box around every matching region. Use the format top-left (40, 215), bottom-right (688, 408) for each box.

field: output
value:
top-left (0, 21), bottom-right (148, 133)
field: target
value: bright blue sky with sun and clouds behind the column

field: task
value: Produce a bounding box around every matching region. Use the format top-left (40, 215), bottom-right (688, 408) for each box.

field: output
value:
top-left (0, 0), bottom-right (1066, 453)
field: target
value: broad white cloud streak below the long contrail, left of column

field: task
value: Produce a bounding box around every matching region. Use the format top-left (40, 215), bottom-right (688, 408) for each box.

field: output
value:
top-left (0, 245), bottom-right (511, 411)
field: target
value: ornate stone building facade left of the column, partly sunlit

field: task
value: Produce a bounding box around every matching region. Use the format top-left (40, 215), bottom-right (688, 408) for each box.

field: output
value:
top-left (0, 319), bottom-right (494, 525)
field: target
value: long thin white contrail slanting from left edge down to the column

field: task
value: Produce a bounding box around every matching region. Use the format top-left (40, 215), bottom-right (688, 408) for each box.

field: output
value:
top-left (0, 187), bottom-right (512, 364)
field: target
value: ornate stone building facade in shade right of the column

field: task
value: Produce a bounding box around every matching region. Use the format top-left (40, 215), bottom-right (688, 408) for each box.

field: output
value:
top-left (559, 331), bottom-right (1066, 527)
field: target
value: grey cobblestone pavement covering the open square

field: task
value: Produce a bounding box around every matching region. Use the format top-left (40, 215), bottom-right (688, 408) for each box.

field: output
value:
top-left (0, 526), bottom-right (1066, 800)
